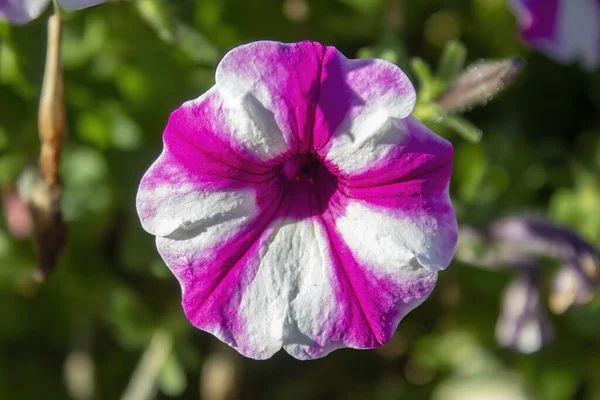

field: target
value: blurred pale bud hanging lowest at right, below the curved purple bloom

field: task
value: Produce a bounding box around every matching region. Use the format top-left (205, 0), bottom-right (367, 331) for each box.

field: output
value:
top-left (496, 270), bottom-right (554, 354)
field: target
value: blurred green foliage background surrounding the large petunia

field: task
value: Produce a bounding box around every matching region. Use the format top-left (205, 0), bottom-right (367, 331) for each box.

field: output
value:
top-left (0, 0), bottom-right (600, 400)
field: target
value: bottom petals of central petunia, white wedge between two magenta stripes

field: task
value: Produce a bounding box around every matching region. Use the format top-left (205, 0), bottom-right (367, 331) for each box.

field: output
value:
top-left (157, 188), bottom-right (437, 359)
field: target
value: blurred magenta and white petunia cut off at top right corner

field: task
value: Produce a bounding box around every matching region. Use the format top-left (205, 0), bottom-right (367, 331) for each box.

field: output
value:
top-left (509, 0), bottom-right (600, 69)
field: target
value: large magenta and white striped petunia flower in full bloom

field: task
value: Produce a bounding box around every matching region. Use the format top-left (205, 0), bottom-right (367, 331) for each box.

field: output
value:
top-left (137, 41), bottom-right (457, 359)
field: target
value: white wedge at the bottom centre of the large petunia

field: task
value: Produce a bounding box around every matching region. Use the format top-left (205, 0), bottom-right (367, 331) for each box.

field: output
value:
top-left (240, 219), bottom-right (336, 359)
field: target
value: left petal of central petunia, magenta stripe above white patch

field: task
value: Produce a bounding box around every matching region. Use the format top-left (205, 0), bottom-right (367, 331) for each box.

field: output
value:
top-left (137, 91), bottom-right (282, 239)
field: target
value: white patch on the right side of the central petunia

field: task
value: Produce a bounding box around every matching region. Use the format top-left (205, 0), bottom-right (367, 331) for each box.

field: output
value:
top-left (336, 201), bottom-right (457, 278)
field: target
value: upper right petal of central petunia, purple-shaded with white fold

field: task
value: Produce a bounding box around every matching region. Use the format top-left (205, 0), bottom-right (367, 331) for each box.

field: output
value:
top-left (314, 51), bottom-right (416, 173)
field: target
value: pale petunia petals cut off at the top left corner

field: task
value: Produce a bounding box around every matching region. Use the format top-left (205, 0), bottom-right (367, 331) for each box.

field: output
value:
top-left (0, 0), bottom-right (118, 24)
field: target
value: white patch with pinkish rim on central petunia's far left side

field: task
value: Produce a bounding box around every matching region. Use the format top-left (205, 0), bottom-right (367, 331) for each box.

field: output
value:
top-left (136, 151), bottom-right (259, 241)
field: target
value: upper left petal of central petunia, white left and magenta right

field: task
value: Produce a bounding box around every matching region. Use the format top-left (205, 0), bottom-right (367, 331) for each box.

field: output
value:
top-left (216, 41), bottom-right (325, 160)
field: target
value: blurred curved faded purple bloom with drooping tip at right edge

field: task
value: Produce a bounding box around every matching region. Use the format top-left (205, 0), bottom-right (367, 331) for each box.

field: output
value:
top-left (456, 217), bottom-right (600, 314)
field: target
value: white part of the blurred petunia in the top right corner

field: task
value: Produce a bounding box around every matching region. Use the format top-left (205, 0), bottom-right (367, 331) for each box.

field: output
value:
top-left (558, 0), bottom-right (600, 69)
